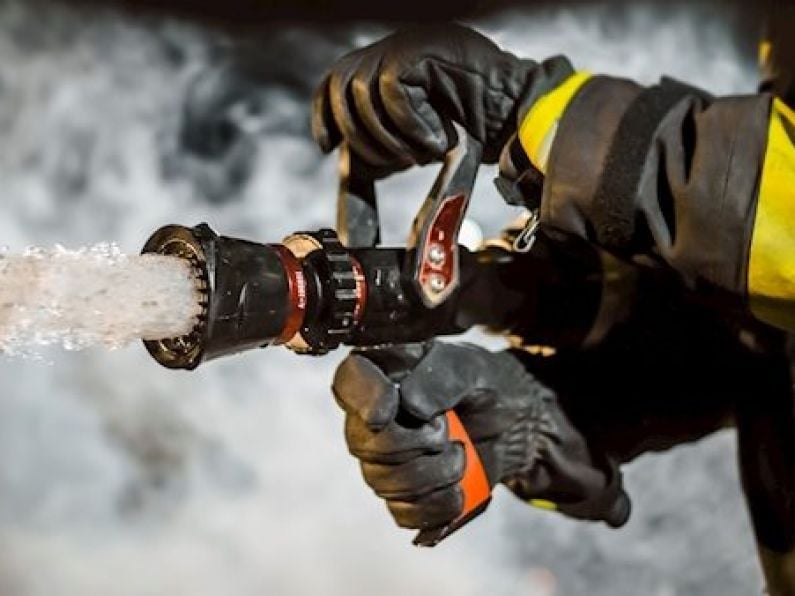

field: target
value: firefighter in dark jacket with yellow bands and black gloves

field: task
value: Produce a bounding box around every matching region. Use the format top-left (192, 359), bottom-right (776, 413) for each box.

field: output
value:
top-left (312, 12), bottom-right (795, 594)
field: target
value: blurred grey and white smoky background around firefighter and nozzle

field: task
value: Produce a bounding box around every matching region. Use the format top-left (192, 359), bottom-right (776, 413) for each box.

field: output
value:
top-left (0, 0), bottom-right (772, 596)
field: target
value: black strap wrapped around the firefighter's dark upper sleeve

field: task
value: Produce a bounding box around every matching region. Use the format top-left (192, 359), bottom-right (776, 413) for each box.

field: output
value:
top-left (593, 78), bottom-right (706, 252)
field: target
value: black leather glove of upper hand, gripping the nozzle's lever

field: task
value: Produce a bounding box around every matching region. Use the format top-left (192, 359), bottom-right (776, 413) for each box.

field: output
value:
top-left (312, 24), bottom-right (572, 176)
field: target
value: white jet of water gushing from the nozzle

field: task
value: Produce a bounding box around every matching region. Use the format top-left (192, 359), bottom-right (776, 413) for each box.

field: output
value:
top-left (0, 243), bottom-right (199, 355)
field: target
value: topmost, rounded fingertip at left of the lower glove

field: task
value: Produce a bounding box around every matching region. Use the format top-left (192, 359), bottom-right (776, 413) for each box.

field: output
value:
top-left (331, 354), bottom-right (399, 430)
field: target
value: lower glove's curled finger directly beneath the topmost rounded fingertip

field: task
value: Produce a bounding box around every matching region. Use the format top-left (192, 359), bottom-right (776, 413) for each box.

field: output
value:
top-left (345, 416), bottom-right (448, 464)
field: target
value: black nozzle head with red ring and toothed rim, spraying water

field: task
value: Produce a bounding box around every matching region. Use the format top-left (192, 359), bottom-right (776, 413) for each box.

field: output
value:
top-left (142, 224), bottom-right (367, 369)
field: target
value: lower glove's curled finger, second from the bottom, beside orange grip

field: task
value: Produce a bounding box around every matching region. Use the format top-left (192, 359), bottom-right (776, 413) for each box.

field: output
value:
top-left (362, 443), bottom-right (465, 501)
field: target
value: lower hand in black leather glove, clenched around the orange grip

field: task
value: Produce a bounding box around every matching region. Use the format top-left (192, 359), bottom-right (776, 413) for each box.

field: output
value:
top-left (333, 342), bottom-right (630, 529)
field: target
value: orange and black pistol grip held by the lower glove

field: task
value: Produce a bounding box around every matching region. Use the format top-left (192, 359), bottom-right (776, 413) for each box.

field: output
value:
top-left (414, 410), bottom-right (491, 547)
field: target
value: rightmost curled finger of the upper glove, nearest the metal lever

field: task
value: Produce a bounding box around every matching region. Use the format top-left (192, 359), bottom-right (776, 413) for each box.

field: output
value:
top-left (378, 61), bottom-right (450, 162)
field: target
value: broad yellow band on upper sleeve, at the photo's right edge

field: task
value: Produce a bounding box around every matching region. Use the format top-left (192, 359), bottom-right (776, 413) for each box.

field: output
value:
top-left (748, 99), bottom-right (795, 331)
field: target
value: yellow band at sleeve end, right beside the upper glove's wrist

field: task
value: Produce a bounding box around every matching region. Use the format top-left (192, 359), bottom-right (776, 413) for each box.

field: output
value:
top-left (519, 72), bottom-right (592, 173)
